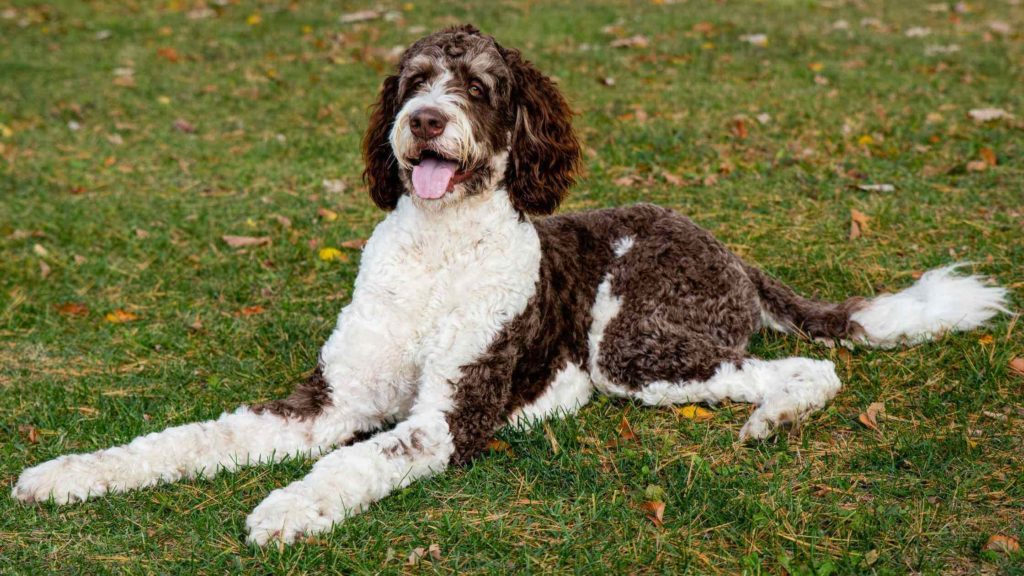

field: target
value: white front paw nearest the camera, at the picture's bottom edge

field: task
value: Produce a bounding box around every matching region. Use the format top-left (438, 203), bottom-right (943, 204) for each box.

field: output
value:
top-left (246, 483), bottom-right (341, 546)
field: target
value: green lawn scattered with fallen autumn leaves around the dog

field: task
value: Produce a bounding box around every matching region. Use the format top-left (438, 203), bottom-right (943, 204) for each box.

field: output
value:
top-left (0, 0), bottom-right (1024, 575)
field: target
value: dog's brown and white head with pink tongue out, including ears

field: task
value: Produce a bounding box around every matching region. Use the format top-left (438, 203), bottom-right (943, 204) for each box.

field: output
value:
top-left (362, 26), bottom-right (580, 214)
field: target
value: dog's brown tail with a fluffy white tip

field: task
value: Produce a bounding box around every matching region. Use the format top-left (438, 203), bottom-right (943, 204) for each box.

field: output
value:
top-left (746, 264), bottom-right (1009, 347)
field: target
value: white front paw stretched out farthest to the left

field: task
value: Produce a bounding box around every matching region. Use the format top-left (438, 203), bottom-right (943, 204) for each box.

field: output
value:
top-left (10, 455), bottom-right (109, 504)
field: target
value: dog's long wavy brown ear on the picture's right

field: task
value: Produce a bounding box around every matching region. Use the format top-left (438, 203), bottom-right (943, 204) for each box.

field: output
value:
top-left (505, 50), bottom-right (580, 214)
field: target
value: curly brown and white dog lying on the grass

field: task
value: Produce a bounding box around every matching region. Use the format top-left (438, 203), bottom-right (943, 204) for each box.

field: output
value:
top-left (13, 26), bottom-right (1006, 544)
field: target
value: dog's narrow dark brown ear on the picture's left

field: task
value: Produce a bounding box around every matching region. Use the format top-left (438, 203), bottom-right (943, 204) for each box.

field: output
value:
top-left (362, 76), bottom-right (403, 210)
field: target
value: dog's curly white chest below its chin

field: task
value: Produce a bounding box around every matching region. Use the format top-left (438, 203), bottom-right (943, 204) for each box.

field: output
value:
top-left (357, 194), bottom-right (541, 365)
